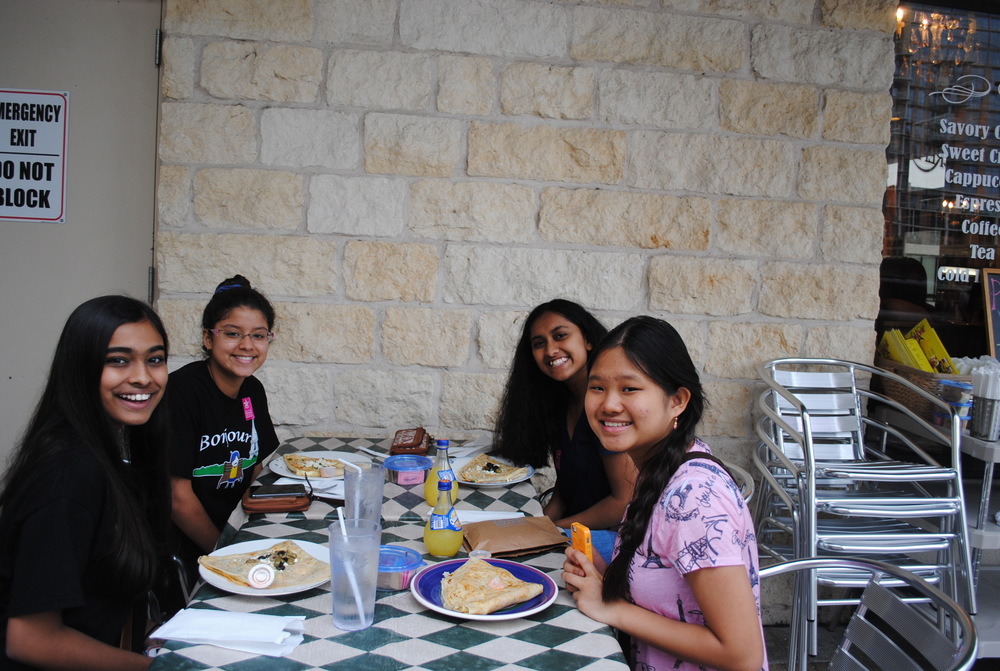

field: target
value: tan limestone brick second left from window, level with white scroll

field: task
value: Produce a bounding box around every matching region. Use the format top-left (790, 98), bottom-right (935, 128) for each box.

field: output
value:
top-left (719, 79), bottom-right (819, 138)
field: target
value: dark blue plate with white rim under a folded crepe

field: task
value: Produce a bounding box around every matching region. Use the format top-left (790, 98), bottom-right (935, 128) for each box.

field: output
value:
top-left (410, 559), bottom-right (559, 622)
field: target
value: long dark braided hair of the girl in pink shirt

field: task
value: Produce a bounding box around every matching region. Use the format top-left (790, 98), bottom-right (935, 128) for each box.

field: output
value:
top-left (590, 316), bottom-right (706, 601)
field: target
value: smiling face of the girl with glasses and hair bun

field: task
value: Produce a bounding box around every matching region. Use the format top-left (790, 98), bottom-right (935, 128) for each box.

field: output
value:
top-left (203, 307), bottom-right (269, 398)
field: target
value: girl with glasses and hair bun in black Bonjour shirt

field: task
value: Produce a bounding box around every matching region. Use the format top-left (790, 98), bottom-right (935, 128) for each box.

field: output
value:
top-left (168, 275), bottom-right (278, 610)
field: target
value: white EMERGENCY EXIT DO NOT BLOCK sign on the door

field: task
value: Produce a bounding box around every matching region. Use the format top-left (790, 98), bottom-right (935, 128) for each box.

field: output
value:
top-left (0, 88), bottom-right (69, 223)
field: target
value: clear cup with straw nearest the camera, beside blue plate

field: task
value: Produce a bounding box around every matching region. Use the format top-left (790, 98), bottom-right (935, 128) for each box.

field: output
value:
top-left (328, 518), bottom-right (382, 631)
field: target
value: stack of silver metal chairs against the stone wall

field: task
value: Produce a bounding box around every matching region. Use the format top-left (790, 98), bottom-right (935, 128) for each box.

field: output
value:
top-left (753, 358), bottom-right (976, 654)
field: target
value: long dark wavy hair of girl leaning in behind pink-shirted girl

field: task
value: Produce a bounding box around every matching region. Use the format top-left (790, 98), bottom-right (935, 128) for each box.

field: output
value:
top-left (493, 298), bottom-right (608, 468)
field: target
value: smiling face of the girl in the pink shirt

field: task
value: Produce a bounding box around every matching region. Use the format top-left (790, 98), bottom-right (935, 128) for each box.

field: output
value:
top-left (586, 347), bottom-right (691, 463)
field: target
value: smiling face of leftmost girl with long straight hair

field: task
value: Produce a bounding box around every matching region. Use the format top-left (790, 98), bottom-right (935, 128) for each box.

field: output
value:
top-left (101, 321), bottom-right (167, 426)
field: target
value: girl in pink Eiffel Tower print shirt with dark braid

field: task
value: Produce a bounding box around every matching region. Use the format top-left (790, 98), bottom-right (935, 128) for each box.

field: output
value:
top-left (563, 317), bottom-right (767, 671)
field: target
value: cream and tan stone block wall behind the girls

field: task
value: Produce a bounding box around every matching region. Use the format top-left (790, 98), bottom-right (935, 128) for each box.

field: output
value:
top-left (155, 0), bottom-right (895, 466)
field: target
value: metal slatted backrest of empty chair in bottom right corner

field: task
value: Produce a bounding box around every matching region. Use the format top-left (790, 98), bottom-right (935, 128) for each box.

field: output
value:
top-left (760, 558), bottom-right (979, 671)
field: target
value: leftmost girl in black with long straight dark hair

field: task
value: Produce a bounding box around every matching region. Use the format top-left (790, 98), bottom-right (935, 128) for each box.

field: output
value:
top-left (0, 296), bottom-right (170, 669)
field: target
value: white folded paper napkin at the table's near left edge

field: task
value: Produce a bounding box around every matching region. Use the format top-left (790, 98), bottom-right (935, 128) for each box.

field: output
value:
top-left (152, 608), bottom-right (305, 657)
